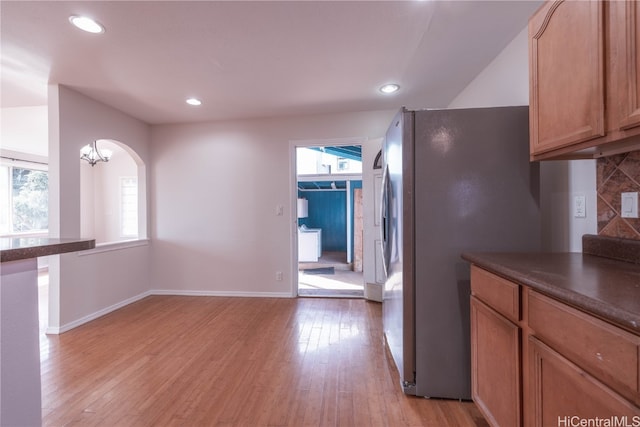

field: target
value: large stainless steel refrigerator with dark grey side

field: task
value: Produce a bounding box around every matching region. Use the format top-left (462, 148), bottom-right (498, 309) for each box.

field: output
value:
top-left (381, 107), bottom-right (541, 399)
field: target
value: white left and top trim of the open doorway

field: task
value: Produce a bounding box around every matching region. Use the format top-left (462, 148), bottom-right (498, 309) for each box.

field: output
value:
top-left (289, 137), bottom-right (369, 298)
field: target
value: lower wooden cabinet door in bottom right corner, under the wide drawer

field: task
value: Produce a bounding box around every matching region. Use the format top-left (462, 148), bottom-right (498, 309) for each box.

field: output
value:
top-left (528, 336), bottom-right (640, 427)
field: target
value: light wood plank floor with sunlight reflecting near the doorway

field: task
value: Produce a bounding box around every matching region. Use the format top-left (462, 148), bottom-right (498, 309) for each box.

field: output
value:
top-left (42, 296), bottom-right (487, 427)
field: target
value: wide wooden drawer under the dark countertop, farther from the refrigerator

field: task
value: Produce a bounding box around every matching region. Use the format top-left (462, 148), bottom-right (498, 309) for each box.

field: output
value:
top-left (528, 290), bottom-right (640, 403)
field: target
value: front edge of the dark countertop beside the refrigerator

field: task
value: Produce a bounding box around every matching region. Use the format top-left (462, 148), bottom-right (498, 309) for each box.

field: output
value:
top-left (462, 253), bottom-right (640, 335)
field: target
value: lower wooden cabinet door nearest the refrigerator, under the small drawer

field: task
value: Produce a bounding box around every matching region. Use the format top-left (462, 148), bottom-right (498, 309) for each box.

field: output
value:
top-left (471, 297), bottom-right (522, 427)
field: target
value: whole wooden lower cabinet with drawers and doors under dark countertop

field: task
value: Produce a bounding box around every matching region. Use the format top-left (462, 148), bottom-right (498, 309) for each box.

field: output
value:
top-left (471, 266), bottom-right (640, 427)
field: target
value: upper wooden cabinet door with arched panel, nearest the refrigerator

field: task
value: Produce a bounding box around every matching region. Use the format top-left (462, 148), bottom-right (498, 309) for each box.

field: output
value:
top-left (529, 1), bottom-right (605, 154)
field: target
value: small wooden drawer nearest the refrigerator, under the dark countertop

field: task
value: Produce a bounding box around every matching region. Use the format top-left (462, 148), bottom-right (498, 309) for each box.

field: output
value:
top-left (471, 265), bottom-right (520, 323)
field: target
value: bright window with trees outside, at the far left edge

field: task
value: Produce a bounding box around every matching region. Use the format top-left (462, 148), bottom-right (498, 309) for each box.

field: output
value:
top-left (0, 165), bottom-right (49, 234)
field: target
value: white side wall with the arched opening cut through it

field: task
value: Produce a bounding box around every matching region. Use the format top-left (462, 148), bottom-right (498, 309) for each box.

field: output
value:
top-left (48, 85), bottom-right (150, 332)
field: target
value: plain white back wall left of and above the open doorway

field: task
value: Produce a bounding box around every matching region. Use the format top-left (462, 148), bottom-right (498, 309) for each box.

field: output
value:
top-left (151, 111), bottom-right (395, 296)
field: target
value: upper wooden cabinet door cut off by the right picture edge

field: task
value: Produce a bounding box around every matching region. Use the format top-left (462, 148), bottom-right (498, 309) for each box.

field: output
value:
top-left (610, 1), bottom-right (640, 129)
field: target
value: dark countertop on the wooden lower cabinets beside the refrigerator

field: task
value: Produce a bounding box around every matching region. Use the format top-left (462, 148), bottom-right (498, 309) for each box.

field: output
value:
top-left (462, 253), bottom-right (640, 334)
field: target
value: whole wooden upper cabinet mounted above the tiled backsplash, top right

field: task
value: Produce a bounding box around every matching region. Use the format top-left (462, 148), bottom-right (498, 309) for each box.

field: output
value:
top-left (529, 0), bottom-right (640, 160)
